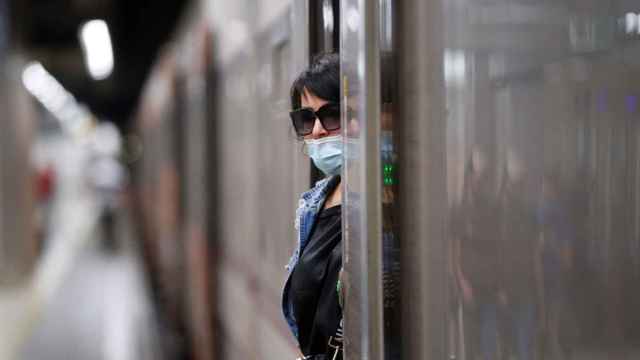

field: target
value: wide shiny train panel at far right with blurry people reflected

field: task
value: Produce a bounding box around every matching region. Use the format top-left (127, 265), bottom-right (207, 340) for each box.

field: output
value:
top-left (442, 0), bottom-right (640, 360)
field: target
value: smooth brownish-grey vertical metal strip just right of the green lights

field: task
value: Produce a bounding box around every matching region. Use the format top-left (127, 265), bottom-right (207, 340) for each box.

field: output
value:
top-left (396, 1), bottom-right (447, 359)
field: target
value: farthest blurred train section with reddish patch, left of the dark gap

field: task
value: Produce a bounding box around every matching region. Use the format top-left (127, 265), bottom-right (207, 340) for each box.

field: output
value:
top-left (129, 32), bottom-right (207, 358)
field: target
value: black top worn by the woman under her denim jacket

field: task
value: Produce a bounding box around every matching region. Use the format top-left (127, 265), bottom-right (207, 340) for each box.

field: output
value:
top-left (291, 206), bottom-right (342, 355)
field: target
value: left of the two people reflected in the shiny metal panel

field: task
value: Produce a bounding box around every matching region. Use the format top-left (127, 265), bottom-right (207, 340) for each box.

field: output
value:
top-left (453, 151), bottom-right (500, 360)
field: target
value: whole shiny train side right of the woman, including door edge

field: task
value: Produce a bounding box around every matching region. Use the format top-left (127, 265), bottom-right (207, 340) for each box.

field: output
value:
top-left (341, 0), bottom-right (640, 359)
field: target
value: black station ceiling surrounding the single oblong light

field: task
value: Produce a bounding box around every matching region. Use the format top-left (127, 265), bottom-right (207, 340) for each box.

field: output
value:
top-left (10, 0), bottom-right (189, 128)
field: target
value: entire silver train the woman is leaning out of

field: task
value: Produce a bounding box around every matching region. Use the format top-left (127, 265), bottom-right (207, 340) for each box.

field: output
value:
top-left (132, 0), bottom-right (640, 360)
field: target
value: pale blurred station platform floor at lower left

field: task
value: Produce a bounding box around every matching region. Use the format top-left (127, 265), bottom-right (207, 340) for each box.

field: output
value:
top-left (0, 210), bottom-right (162, 360)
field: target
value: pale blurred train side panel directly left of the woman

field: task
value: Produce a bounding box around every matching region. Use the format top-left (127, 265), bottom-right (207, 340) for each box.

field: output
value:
top-left (201, 0), bottom-right (309, 359)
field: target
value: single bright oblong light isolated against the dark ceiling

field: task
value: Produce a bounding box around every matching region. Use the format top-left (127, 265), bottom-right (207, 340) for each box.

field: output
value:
top-left (80, 20), bottom-right (113, 80)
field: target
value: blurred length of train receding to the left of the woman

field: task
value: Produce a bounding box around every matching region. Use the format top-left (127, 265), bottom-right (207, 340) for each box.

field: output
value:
top-left (133, 2), bottom-right (338, 359)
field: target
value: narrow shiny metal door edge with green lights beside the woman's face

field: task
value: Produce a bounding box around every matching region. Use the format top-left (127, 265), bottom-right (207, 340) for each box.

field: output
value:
top-left (341, 0), bottom-right (402, 359)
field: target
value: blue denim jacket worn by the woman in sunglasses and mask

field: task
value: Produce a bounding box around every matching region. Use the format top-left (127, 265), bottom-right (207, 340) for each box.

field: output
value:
top-left (282, 176), bottom-right (340, 339)
